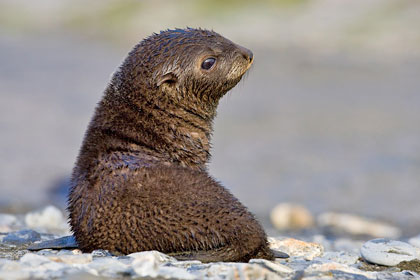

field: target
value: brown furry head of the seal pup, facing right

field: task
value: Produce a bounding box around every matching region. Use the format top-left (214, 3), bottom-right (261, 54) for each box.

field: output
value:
top-left (113, 28), bottom-right (253, 105)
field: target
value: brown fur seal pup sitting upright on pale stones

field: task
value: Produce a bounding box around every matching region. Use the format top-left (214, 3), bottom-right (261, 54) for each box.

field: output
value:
top-left (68, 28), bottom-right (273, 262)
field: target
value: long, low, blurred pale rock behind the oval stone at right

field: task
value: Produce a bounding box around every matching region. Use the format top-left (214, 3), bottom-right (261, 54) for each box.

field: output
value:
top-left (317, 212), bottom-right (401, 238)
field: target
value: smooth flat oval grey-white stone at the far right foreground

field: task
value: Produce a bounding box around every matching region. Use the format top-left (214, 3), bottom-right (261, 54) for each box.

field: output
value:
top-left (360, 238), bottom-right (419, 266)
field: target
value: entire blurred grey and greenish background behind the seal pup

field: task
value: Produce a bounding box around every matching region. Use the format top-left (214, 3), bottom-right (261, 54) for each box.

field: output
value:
top-left (0, 0), bottom-right (420, 234)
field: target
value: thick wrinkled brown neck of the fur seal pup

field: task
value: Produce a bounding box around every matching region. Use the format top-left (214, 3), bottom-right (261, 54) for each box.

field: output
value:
top-left (81, 85), bottom-right (215, 170)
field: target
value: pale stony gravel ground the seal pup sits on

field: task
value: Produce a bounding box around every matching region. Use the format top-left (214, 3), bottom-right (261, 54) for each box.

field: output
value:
top-left (0, 206), bottom-right (420, 280)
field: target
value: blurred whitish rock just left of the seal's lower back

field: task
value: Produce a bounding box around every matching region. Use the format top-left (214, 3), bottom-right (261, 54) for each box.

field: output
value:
top-left (25, 205), bottom-right (71, 235)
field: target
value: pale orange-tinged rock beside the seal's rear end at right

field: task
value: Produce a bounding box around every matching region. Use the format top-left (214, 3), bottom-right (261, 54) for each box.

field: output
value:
top-left (268, 237), bottom-right (324, 260)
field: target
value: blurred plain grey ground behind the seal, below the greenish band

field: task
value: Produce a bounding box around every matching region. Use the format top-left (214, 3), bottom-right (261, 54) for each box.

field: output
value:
top-left (0, 30), bottom-right (420, 232)
